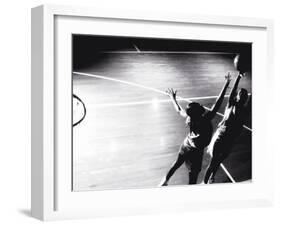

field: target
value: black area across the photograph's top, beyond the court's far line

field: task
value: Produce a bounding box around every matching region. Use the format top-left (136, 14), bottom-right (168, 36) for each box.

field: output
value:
top-left (72, 35), bottom-right (252, 71)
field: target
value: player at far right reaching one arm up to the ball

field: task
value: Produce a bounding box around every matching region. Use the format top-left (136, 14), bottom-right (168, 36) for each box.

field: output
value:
top-left (204, 73), bottom-right (251, 183)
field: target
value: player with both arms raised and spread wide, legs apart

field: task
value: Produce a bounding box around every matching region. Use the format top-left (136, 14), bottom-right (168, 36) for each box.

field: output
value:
top-left (160, 74), bottom-right (230, 186)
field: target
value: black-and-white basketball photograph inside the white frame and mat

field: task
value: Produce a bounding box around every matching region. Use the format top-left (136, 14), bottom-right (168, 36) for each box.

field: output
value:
top-left (71, 34), bottom-right (252, 191)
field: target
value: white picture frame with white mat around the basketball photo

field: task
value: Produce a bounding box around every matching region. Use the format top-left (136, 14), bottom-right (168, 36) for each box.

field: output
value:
top-left (31, 5), bottom-right (273, 220)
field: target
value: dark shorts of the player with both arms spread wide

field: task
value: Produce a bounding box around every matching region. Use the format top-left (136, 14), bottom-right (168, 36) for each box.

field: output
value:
top-left (179, 144), bottom-right (203, 173)
